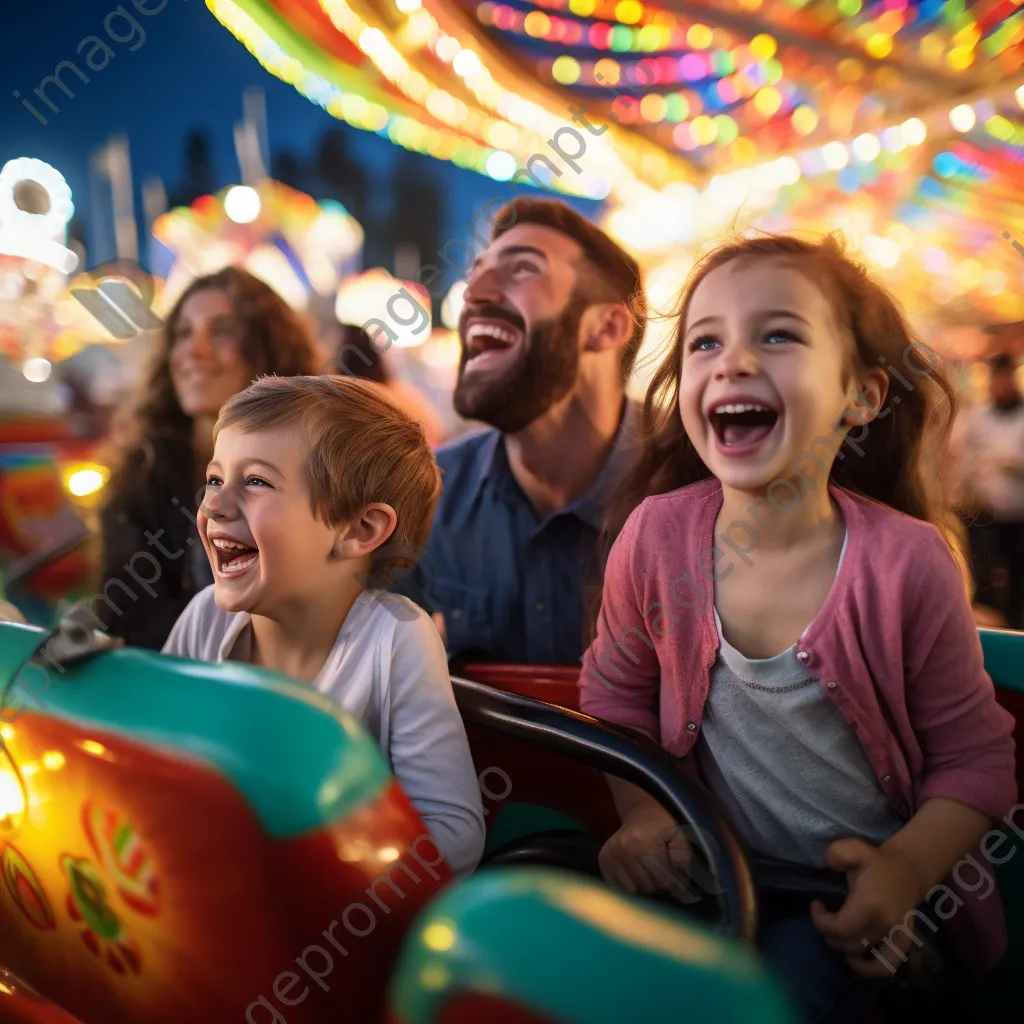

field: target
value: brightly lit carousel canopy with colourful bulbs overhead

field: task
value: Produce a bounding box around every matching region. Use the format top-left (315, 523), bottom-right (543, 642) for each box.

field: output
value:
top-left (207, 0), bottom-right (1024, 390)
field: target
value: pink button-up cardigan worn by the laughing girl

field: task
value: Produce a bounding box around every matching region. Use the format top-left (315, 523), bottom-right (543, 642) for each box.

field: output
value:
top-left (580, 480), bottom-right (1017, 969)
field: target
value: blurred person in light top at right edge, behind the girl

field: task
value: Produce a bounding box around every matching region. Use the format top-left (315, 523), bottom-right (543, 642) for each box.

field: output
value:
top-left (959, 353), bottom-right (1024, 630)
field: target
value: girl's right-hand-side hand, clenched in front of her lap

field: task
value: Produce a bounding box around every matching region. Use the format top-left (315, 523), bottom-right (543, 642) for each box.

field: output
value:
top-left (811, 839), bottom-right (925, 978)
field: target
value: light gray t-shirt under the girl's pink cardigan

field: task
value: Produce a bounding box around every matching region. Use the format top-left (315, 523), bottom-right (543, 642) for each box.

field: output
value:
top-left (697, 546), bottom-right (904, 867)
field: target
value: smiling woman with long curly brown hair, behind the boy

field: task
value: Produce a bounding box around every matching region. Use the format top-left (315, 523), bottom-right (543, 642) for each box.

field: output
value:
top-left (92, 267), bottom-right (317, 649)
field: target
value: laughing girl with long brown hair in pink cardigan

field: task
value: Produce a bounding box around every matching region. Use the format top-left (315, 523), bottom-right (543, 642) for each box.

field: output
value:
top-left (581, 237), bottom-right (1016, 1022)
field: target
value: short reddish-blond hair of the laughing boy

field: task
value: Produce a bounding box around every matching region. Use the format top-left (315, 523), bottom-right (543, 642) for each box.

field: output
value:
top-left (213, 375), bottom-right (441, 587)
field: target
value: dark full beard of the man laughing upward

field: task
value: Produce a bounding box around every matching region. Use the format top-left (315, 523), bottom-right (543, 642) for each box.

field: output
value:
top-left (454, 293), bottom-right (589, 434)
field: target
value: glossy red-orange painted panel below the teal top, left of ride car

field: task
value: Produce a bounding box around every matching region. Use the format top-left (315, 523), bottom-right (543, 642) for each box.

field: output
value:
top-left (0, 712), bottom-right (449, 1024)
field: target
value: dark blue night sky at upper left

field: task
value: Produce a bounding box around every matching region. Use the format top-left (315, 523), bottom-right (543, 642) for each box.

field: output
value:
top-left (0, 0), bottom-right (593, 265)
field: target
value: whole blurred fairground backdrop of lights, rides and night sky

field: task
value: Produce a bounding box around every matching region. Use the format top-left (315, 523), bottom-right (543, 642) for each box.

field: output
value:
top-left (0, 0), bottom-right (1024, 622)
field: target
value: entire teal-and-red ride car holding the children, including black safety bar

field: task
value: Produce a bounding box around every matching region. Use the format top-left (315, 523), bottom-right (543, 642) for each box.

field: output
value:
top-left (0, 624), bottom-right (1024, 1024)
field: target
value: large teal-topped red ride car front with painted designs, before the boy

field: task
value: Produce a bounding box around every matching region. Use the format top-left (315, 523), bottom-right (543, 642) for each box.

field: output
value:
top-left (0, 624), bottom-right (449, 1024)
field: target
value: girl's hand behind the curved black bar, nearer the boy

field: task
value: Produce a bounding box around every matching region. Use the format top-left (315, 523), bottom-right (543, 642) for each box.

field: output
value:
top-left (598, 801), bottom-right (692, 902)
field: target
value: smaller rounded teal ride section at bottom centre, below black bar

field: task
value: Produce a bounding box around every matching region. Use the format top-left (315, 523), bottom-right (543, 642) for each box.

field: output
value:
top-left (388, 868), bottom-right (797, 1024)
